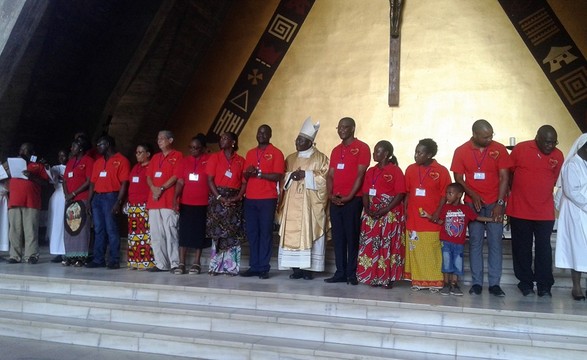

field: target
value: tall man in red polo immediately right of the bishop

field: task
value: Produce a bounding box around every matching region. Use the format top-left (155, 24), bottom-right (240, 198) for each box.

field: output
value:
top-left (324, 117), bottom-right (371, 285)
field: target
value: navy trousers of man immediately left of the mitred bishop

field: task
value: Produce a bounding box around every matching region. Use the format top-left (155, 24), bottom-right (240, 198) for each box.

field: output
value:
top-left (244, 199), bottom-right (277, 272)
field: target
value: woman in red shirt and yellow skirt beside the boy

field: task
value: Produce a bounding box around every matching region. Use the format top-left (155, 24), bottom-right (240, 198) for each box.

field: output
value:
top-left (404, 139), bottom-right (451, 291)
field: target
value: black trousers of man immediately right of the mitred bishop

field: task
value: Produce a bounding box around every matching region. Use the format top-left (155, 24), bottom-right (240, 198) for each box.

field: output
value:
top-left (330, 196), bottom-right (363, 278)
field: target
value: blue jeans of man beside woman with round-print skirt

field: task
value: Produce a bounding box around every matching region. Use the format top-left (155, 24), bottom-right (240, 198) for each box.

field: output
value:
top-left (92, 192), bottom-right (120, 265)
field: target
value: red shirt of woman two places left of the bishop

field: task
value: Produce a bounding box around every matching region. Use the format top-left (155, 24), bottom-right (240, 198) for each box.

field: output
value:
top-left (206, 150), bottom-right (245, 189)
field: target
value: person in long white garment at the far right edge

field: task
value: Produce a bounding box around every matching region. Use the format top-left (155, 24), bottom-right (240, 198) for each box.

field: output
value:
top-left (555, 134), bottom-right (587, 301)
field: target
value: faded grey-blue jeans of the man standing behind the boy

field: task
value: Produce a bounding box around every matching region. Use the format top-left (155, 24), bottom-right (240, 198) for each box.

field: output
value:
top-left (467, 203), bottom-right (503, 286)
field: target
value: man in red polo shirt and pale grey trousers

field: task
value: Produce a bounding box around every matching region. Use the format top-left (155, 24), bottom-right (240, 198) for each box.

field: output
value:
top-left (147, 130), bottom-right (183, 274)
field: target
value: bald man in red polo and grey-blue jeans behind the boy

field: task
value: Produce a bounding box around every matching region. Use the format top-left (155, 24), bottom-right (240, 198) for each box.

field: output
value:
top-left (450, 119), bottom-right (511, 297)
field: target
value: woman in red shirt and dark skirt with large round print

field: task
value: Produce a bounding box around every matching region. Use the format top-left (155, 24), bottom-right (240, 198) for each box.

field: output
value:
top-left (62, 136), bottom-right (94, 267)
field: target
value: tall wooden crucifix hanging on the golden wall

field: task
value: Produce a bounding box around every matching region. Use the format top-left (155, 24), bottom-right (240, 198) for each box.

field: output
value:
top-left (387, 0), bottom-right (403, 106)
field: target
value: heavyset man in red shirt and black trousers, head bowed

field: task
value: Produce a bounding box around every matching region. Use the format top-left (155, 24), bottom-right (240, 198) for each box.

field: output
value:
top-left (506, 125), bottom-right (564, 297)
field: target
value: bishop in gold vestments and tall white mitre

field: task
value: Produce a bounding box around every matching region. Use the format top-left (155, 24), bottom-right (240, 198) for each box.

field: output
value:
top-left (278, 118), bottom-right (329, 280)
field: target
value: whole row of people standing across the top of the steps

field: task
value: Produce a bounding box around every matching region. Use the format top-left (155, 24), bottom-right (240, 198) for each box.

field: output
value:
top-left (0, 117), bottom-right (587, 300)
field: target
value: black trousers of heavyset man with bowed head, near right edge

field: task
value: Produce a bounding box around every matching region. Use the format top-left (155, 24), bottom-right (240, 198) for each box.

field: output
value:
top-left (510, 217), bottom-right (554, 290)
